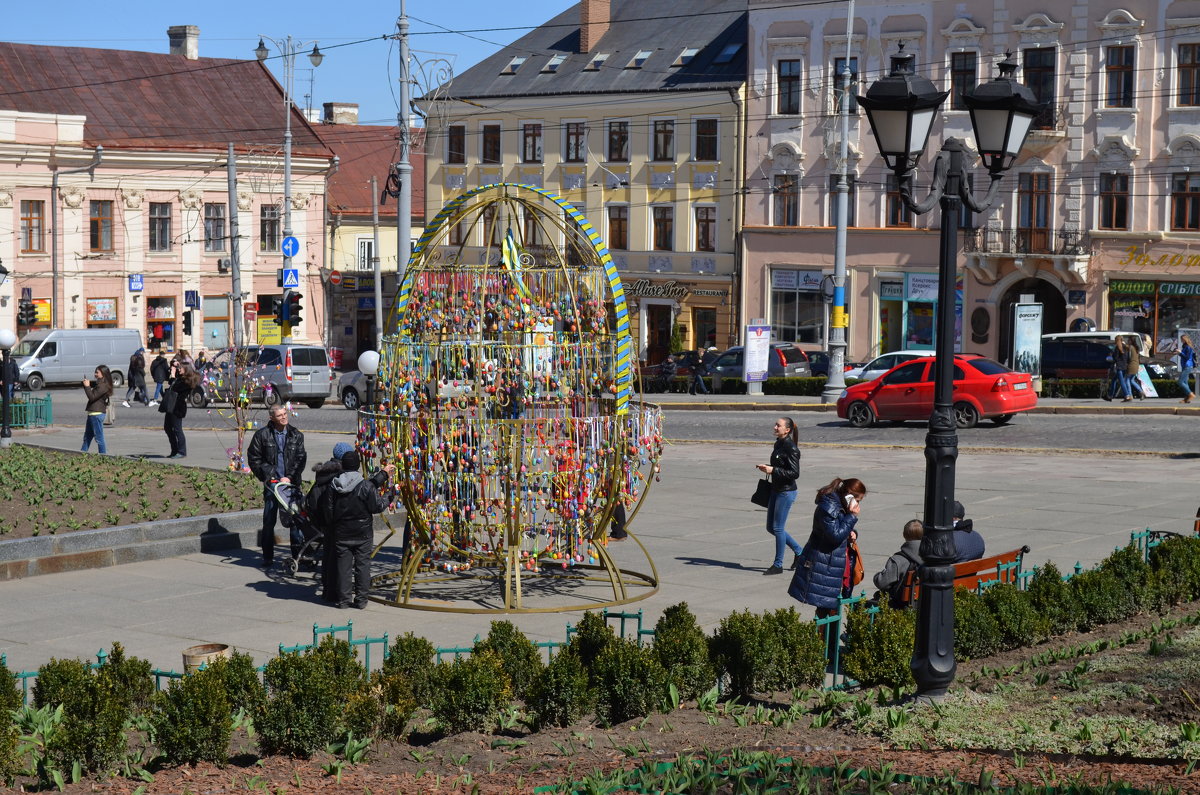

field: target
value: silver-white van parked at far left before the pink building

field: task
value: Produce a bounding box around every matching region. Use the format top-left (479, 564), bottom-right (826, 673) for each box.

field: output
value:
top-left (12, 329), bottom-right (142, 389)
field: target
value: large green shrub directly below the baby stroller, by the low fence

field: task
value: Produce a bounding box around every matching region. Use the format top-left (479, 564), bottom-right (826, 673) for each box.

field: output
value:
top-left (254, 653), bottom-right (343, 758)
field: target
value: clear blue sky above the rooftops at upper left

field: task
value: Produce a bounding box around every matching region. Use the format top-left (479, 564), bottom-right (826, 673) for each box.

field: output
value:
top-left (0, 0), bottom-right (572, 124)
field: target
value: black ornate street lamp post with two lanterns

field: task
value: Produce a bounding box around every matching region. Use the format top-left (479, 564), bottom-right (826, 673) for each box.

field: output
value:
top-left (858, 44), bottom-right (1042, 698)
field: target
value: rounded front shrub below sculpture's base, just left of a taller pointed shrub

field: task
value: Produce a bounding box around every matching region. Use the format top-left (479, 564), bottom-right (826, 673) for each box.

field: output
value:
top-left (593, 638), bottom-right (668, 727)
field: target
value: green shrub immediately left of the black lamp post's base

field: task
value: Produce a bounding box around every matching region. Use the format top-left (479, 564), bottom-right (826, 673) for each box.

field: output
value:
top-left (841, 603), bottom-right (917, 687)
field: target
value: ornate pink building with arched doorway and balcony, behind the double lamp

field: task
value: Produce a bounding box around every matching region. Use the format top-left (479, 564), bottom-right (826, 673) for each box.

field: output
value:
top-left (740, 0), bottom-right (1200, 359)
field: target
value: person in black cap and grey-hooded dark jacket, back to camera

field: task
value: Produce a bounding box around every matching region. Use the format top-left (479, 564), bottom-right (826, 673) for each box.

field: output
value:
top-left (320, 450), bottom-right (396, 610)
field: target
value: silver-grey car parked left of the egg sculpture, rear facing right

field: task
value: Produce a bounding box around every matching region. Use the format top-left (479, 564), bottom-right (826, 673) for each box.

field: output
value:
top-left (190, 345), bottom-right (334, 408)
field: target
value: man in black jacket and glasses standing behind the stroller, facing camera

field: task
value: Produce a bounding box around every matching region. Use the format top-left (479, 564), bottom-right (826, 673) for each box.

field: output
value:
top-left (246, 405), bottom-right (308, 569)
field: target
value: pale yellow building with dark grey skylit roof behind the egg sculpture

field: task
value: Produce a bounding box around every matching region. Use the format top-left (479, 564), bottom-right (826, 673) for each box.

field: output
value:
top-left (417, 0), bottom-right (745, 363)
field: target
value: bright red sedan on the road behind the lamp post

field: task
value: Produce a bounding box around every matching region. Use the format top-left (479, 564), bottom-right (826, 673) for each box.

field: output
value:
top-left (838, 353), bottom-right (1038, 428)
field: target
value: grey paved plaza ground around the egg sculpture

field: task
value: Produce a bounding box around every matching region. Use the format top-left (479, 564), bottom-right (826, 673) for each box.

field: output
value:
top-left (0, 429), bottom-right (1200, 670)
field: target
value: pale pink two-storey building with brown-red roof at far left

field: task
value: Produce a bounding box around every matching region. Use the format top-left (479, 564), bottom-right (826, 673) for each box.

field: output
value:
top-left (0, 25), bottom-right (332, 351)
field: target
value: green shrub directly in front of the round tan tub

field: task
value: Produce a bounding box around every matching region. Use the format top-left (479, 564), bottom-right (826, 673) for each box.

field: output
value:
top-left (150, 667), bottom-right (233, 766)
